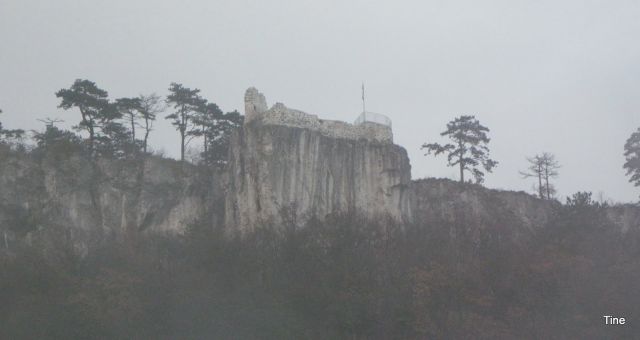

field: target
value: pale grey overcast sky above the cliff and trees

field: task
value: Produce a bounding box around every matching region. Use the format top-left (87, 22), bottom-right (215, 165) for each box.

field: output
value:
top-left (0, 0), bottom-right (640, 202)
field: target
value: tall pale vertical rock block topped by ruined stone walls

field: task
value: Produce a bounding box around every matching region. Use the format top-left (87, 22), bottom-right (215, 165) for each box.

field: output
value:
top-left (225, 89), bottom-right (411, 231)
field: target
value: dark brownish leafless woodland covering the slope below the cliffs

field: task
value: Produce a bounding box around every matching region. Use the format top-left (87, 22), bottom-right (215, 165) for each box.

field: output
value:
top-left (0, 193), bottom-right (640, 339)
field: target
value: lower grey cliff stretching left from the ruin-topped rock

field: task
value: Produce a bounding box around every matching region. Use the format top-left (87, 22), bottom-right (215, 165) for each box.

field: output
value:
top-left (0, 148), bottom-right (223, 253)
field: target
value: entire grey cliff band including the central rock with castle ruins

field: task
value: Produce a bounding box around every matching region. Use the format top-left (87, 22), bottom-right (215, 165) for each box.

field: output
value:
top-left (0, 89), bottom-right (640, 252)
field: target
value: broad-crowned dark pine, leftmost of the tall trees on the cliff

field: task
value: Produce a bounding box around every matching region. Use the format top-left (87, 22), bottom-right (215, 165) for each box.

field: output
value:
top-left (56, 79), bottom-right (122, 156)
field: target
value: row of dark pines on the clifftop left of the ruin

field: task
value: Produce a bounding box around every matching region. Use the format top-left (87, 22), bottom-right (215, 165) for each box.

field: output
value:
top-left (0, 79), bottom-right (244, 168)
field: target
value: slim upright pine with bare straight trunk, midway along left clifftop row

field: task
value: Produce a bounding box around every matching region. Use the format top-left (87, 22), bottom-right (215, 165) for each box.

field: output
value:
top-left (165, 83), bottom-right (202, 161)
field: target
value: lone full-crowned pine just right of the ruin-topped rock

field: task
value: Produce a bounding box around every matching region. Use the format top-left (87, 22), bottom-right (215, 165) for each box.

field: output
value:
top-left (421, 116), bottom-right (498, 183)
